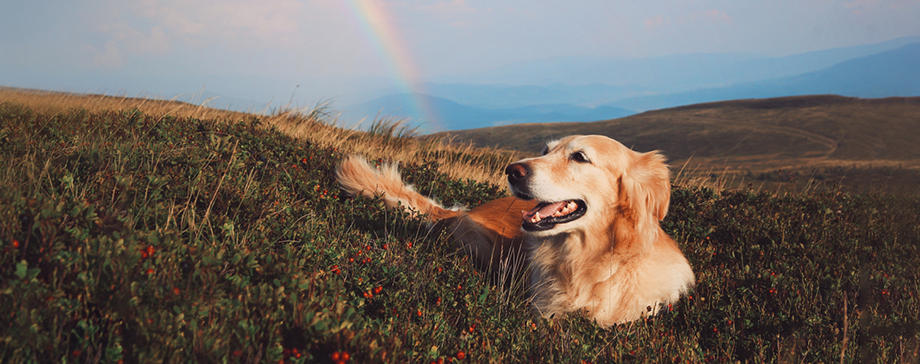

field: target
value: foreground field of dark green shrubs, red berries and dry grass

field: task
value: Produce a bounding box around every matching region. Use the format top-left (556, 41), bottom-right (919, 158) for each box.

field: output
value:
top-left (0, 91), bottom-right (920, 363)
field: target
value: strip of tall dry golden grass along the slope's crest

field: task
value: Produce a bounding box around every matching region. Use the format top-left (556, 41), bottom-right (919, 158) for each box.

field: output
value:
top-left (0, 87), bottom-right (520, 186)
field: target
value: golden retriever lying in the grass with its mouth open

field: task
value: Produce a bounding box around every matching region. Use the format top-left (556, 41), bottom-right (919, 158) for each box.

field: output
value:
top-left (336, 135), bottom-right (695, 328)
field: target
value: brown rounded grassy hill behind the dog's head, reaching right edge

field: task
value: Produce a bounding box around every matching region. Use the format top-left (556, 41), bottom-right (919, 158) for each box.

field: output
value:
top-left (434, 96), bottom-right (920, 195)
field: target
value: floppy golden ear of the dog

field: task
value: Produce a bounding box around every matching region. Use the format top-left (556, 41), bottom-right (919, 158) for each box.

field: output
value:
top-left (619, 151), bottom-right (671, 223)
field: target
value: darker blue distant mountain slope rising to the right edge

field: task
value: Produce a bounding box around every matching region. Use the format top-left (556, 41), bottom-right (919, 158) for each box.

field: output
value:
top-left (609, 43), bottom-right (920, 110)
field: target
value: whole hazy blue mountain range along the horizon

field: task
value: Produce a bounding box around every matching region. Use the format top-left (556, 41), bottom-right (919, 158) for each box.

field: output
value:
top-left (341, 37), bottom-right (920, 131)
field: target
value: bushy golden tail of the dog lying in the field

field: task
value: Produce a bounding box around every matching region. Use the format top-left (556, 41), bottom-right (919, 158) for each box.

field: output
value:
top-left (335, 155), bottom-right (462, 221)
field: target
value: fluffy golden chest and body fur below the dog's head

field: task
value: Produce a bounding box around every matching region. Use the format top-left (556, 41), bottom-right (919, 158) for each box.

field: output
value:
top-left (526, 232), bottom-right (693, 327)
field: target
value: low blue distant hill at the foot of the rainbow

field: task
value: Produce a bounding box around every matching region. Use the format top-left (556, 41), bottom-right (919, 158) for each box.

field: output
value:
top-left (342, 93), bottom-right (633, 130)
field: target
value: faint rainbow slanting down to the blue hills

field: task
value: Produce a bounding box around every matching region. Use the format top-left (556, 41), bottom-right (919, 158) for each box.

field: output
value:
top-left (346, 0), bottom-right (443, 130)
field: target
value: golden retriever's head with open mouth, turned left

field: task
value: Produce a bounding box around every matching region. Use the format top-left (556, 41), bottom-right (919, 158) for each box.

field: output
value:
top-left (505, 135), bottom-right (671, 236)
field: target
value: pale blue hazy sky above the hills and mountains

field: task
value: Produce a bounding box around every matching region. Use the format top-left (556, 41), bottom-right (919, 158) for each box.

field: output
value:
top-left (0, 0), bottom-right (920, 108)
